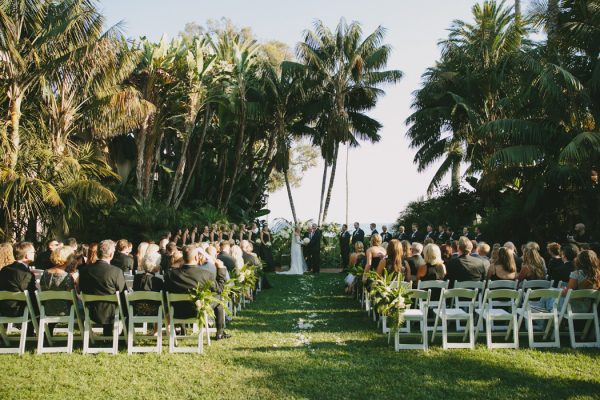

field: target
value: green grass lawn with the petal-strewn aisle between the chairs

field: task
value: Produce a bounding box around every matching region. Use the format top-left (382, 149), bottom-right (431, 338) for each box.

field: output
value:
top-left (0, 274), bottom-right (600, 399)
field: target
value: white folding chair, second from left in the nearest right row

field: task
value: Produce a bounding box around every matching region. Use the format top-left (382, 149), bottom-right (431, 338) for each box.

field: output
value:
top-left (431, 289), bottom-right (477, 349)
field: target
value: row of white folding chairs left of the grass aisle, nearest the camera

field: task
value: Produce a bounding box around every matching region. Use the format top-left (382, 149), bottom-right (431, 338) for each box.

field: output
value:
top-left (0, 290), bottom-right (253, 354)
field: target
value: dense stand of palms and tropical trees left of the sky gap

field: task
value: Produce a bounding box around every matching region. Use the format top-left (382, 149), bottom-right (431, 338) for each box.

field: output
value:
top-left (0, 0), bottom-right (401, 241)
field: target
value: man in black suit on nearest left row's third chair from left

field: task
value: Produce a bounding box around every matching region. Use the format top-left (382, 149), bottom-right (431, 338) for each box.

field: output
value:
top-left (79, 240), bottom-right (126, 336)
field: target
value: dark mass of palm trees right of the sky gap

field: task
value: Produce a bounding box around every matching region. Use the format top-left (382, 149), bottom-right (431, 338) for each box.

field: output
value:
top-left (398, 0), bottom-right (600, 245)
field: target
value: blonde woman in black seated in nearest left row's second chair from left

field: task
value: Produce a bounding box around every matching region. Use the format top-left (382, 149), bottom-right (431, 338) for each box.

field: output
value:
top-left (40, 246), bottom-right (75, 315)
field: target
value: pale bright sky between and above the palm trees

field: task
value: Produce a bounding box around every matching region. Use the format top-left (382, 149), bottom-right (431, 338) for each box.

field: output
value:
top-left (100, 0), bottom-right (524, 223)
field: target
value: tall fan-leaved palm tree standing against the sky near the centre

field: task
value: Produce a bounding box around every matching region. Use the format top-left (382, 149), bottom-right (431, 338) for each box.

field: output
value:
top-left (297, 19), bottom-right (402, 224)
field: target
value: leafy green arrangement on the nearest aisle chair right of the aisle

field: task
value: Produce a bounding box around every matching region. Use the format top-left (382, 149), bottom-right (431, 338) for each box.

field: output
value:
top-left (369, 270), bottom-right (411, 329)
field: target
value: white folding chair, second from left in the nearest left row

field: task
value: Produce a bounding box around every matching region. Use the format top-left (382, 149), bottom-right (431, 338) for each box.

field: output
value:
top-left (35, 290), bottom-right (83, 354)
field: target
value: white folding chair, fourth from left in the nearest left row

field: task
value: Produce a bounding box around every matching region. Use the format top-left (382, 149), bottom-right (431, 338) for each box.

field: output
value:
top-left (125, 291), bottom-right (165, 354)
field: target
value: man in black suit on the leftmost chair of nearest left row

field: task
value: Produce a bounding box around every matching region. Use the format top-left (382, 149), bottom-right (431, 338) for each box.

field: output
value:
top-left (0, 242), bottom-right (37, 320)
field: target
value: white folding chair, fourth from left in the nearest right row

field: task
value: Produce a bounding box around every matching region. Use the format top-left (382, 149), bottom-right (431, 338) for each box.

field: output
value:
top-left (506, 288), bottom-right (561, 348)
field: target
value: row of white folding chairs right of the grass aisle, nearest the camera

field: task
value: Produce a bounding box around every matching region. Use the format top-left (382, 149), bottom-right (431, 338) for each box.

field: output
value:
top-left (364, 281), bottom-right (600, 351)
